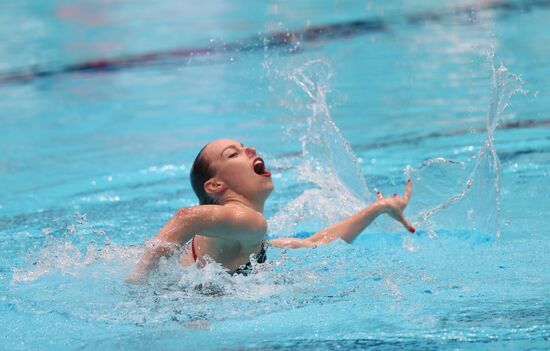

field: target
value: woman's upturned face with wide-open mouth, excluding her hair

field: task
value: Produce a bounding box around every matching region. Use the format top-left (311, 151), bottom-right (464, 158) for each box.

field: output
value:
top-left (204, 139), bottom-right (273, 201)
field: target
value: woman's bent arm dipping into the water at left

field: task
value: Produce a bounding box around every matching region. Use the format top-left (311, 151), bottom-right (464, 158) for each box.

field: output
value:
top-left (126, 205), bottom-right (261, 283)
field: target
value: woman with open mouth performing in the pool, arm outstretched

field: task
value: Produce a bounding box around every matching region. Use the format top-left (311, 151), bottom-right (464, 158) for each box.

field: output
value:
top-left (127, 139), bottom-right (415, 283)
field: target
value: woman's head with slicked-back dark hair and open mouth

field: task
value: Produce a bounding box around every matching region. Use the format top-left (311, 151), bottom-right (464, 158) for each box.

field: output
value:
top-left (190, 139), bottom-right (273, 205)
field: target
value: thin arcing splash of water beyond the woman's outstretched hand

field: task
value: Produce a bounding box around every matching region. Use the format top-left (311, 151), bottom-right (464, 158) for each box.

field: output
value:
top-left (406, 53), bottom-right (526, 238)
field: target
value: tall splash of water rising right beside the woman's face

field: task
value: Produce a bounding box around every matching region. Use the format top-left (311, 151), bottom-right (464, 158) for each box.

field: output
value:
top-left (270, 59), bottom-right (371, 234)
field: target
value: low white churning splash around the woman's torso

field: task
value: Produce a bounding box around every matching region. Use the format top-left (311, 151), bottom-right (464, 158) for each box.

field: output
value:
top-left (8, 220), bottom-right (374, 329)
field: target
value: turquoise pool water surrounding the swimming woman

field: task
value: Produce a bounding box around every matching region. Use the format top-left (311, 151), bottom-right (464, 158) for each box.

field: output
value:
top-left (0, 1), bottom-right (550, 350)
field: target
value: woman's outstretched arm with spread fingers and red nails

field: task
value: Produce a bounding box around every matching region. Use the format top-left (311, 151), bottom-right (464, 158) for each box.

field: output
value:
top-left (271, 179), bottom-right (415, 248)
